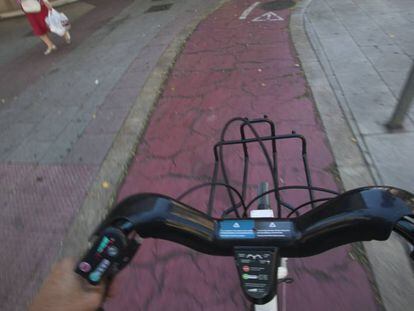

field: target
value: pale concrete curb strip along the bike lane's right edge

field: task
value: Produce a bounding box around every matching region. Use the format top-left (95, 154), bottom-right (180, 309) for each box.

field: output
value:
top-left (290, 0), bottom-right (412, 311)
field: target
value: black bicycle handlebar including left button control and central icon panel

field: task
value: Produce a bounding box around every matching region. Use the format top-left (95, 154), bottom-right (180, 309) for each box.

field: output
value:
top-left (75, 187), bottom-right (414, 304)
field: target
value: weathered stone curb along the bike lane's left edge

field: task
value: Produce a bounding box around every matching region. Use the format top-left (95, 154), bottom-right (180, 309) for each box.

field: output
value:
top-left (57, 0), bottom-right (228, 259)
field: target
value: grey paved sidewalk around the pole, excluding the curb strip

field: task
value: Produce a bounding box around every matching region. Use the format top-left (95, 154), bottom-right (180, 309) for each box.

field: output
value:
top-left (306, 0), bottom-right (414, 191)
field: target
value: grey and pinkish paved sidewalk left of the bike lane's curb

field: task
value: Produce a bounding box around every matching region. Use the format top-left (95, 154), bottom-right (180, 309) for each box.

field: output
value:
top-left (0, 0), bottom-right (222, 311)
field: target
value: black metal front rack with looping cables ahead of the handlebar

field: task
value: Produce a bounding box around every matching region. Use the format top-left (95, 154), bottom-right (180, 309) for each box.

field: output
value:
top-left (178, 116), bottom-right (339, 218)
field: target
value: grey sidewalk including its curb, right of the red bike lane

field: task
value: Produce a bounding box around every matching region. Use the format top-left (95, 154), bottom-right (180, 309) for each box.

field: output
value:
top-left (291, 0), bottom-right (414, 311)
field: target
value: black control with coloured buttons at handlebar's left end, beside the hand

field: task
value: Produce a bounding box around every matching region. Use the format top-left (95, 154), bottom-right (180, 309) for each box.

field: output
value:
top-left (75, 227), bottom-right (133, 285)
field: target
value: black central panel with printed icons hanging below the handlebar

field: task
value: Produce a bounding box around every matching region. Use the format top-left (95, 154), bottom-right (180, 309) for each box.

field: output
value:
top-left (235, 247), bottom-right (280, 304)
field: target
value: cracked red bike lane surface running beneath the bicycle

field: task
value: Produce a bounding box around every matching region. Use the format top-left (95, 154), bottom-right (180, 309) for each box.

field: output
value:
top-left (106, 1), bottom-right (380, 310)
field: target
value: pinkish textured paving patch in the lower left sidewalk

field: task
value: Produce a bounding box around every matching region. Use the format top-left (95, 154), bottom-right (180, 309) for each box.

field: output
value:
top-left (0, 163), bottom-right (98, 311)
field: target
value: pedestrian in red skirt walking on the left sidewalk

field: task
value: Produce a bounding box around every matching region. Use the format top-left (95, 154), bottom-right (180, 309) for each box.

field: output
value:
top-left (17, 0), bottom-right (70, 55)
